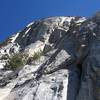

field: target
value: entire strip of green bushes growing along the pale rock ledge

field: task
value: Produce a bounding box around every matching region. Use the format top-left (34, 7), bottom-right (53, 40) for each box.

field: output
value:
top-left (5, 50), bottom-right (43, 71)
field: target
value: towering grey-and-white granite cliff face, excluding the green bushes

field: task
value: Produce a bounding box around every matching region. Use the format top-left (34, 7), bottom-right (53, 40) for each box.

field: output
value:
top-left (0, 13), bottom-right (100, 100)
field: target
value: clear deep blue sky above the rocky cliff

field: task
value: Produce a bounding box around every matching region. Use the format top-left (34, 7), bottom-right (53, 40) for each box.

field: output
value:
top-left (0, 0), bottom-right (100, 41)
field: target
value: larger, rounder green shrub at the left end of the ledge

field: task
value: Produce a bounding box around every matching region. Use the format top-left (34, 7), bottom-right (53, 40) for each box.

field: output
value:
top-left (5, 53), bottom-right (27, 71)
